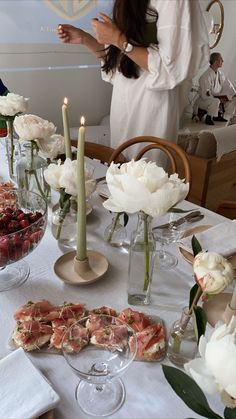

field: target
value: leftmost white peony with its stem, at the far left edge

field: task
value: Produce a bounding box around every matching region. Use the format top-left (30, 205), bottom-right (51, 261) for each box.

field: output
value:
top-left (0, 93), bottom-right (28, 178)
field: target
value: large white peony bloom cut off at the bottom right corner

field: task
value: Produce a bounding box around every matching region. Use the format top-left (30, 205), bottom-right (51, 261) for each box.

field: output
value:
top-left (184, 316), bottom-right (236, 408)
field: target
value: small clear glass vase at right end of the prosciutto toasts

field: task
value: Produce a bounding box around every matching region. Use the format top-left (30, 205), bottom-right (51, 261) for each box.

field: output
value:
top-left (167, 307), bottom-right (198, 367)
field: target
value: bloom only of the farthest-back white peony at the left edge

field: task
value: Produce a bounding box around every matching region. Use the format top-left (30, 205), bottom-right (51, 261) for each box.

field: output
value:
top-left (0, 93), bottom-right (29, 116)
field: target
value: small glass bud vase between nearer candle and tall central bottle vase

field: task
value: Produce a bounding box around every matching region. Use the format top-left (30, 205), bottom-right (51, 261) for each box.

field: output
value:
top-left (104, 213), bottom-right (127, 247)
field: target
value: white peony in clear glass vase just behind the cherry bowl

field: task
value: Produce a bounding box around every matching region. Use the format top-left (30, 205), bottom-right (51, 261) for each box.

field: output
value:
top-left (14, 115), bottom-right (56, 198)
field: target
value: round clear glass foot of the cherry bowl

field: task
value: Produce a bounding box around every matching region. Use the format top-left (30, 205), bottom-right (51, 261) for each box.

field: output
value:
top-left (0, 260), bottom-right (30, 292)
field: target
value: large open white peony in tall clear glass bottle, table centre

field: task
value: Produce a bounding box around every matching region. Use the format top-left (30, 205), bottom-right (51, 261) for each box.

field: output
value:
top-left (103, 159), bottom-right (189, 304)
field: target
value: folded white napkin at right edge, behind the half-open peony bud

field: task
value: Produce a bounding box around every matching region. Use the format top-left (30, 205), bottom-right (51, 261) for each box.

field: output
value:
top-left (180, 220), bottom-right (236, 257)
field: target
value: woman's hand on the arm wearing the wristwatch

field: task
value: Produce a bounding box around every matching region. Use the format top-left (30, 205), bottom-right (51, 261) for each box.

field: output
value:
top-left (91, 13), bottom-right (122, 48)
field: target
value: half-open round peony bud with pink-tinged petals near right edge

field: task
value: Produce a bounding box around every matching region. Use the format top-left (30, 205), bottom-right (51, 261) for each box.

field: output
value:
top-left (193, 252), bottom-right (234, 294)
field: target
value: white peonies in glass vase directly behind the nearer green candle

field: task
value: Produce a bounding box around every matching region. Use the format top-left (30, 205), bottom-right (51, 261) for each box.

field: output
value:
top-left (44, 158), bottom-right (96, 240)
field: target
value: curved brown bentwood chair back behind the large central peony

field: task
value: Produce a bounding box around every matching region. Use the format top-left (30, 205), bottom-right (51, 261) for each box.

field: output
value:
top-left (108, 136), bottom-right (191, 182)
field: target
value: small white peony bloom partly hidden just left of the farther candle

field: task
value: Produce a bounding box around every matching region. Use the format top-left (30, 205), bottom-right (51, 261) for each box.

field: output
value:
top-left (37, 134), bottom-right (65, 160)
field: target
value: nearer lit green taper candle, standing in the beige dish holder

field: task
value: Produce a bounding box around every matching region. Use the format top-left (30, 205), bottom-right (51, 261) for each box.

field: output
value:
top-left (76, 116), bottom-right (87, 261)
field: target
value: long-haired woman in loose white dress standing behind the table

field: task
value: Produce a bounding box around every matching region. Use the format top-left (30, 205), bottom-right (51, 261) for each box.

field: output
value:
top-left (58, 0), bottom-right (209, 158)
